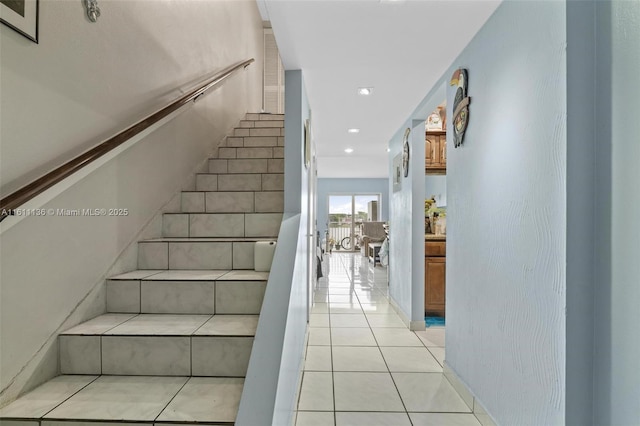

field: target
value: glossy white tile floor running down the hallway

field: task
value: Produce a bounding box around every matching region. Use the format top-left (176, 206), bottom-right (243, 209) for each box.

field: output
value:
top-left (296, 253), bottom-right (480, 426)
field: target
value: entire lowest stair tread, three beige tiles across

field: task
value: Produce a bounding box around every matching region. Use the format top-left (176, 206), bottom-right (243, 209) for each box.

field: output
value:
top-left (0, 375), bottom-right (244, 424)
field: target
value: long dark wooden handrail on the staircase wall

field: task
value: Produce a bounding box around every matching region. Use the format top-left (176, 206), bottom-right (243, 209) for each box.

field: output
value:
top-left (0, 58), bottom-right (255, 221)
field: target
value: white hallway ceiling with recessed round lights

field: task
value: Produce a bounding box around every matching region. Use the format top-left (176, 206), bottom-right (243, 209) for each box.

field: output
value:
top-left (258, 0), bottom-right (500, 177)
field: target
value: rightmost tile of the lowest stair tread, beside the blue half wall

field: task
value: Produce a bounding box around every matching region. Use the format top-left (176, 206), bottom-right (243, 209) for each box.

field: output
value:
top-left (157, 377), bottom-right (244, 422)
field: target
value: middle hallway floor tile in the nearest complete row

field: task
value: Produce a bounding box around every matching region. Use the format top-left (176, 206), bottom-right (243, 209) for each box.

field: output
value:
top-left (333, 372), bottom-right (404, 411)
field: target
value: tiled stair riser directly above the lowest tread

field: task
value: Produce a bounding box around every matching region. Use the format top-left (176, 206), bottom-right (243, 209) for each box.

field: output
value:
top-left (59, 335), bottom-right (254, 377)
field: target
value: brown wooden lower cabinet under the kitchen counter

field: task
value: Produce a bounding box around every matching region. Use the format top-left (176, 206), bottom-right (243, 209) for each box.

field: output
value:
top-left (424, 241), bottom-right (447, 317)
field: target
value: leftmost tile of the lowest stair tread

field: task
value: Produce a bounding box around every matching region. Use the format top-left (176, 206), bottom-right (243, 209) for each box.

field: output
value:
top-left (0, 376), bottom-right (97, 418)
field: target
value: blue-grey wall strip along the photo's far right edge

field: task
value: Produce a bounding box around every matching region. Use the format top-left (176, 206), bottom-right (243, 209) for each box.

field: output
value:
top-left (593, 0), bottom-right (640, 425)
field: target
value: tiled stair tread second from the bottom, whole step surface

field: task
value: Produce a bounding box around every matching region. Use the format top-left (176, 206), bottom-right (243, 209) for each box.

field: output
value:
top-left (60, 314), bottom-right (259, 337)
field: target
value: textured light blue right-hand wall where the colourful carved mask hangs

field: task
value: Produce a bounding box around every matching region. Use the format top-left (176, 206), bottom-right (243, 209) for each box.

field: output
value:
top-left (420, 1), bottom-right (567, 425)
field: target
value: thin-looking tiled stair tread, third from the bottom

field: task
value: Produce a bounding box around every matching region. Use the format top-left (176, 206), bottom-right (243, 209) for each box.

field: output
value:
top-left (108, 269), bottom-right (269, 281)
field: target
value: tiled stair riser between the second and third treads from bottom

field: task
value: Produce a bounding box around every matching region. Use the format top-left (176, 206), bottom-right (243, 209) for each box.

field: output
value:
top-left (107, 278), bottom-right (267, 315)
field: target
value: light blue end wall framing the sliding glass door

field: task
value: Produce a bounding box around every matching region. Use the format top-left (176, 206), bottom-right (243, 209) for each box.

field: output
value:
top-left (317, 178), bottom-right (389, 236)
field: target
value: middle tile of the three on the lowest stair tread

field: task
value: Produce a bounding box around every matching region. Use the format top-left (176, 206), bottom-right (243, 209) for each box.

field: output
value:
top-left (45, 376), bottom-right (187, 421)
